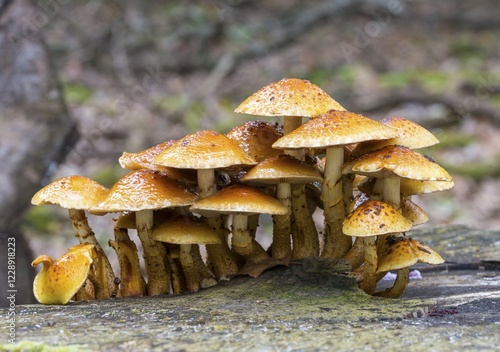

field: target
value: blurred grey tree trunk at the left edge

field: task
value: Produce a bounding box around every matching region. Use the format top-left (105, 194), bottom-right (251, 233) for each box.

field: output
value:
top-left (0, 0), bottom-right (78, 305)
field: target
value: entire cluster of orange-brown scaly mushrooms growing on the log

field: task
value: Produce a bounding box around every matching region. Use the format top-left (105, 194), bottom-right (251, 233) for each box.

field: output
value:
top-left (32, 78), bottom-right (453, 304)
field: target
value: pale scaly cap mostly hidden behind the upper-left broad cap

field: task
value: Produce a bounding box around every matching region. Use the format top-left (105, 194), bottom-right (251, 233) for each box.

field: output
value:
top-left (118, 139), bottom-right (196, 183)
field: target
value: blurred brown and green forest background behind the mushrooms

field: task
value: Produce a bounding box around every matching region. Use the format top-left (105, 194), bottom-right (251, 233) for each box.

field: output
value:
top-left (0, 0), bottom-right (500, 302)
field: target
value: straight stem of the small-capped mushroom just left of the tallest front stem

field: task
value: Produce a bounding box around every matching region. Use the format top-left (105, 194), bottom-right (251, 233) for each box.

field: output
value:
top-left (271, 183), bottom-right (292, 258)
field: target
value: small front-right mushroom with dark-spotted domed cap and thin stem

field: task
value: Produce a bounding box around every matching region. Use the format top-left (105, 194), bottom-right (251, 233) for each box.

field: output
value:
top-left (342, 200), bottom-right (411, 294)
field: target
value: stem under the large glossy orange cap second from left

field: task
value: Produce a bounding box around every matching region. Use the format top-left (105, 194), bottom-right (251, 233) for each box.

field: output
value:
top-left (136, 209), bottom-right (170, 296)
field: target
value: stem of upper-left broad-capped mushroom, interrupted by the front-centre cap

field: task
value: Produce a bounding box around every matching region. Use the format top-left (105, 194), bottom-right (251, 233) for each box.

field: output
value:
top-left (198, 169), bottom-right (238, 280)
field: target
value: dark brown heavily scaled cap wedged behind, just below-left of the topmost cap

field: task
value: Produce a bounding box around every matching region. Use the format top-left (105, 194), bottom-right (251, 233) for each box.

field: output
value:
top-left (226, 121), bottom-right (283, 162)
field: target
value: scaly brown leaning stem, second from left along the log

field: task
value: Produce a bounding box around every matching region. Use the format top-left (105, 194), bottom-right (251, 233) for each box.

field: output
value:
top-left (108, 226), bottom-right (147, 297)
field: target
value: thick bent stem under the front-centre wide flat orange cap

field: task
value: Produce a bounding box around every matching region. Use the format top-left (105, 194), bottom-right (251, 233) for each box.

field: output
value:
top-left (232, 214), bottom-right (269, 263)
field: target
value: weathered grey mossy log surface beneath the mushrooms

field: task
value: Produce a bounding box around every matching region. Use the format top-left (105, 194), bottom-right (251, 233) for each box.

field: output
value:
top-left (0, 226), bottom-right (500, 351)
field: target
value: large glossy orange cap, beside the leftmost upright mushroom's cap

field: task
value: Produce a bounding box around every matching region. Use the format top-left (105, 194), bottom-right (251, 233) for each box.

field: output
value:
top-left (91, 170), bottom-right (197, 212)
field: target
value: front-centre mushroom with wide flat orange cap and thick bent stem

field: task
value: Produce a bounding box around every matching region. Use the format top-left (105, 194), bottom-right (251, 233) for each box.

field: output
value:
top-left (189, 184), bottom-right (288, 263)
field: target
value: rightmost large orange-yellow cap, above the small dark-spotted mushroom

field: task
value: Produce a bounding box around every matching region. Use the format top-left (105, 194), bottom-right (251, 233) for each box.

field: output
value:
top-left (342, 145), bottom-right (451, 181)
